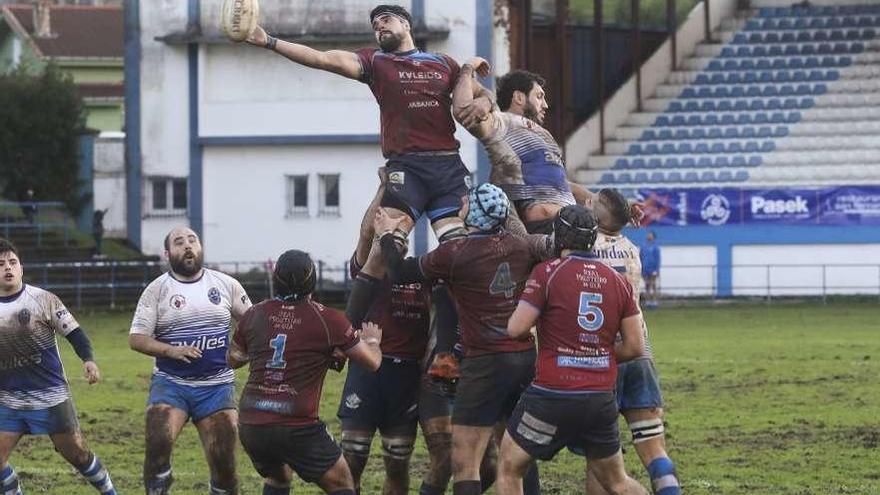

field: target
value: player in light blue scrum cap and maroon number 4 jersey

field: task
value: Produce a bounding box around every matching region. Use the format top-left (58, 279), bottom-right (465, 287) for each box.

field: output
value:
top-left (376, 183), bottom-right (551, 495)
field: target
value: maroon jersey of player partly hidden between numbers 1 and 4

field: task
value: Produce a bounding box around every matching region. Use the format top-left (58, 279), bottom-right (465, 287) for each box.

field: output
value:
top-left (349, 256), bottom-right (431, 360)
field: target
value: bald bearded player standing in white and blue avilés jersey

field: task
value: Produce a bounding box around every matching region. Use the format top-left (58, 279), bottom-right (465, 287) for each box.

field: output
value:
top-left (128, 227), bottom-right (251, 495)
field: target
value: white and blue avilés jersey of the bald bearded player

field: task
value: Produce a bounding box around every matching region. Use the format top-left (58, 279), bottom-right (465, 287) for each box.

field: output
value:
top-left (131, 268), bottom-right (251, 386)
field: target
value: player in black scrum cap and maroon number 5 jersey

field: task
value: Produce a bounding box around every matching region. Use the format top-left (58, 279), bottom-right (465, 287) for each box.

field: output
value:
top-left (497, 205), bottom-right (647, 495)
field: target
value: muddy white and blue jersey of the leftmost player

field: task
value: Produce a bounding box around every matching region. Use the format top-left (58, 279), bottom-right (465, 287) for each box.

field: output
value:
top-left (0, 285), bottom-right (79, 410)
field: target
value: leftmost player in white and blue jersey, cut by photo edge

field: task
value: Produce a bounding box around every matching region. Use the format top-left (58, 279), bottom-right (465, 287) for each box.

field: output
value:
top-left (0, 239), bottom-right (116, 495)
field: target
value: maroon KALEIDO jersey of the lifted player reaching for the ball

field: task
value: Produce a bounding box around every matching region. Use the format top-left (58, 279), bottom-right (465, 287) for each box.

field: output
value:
top-left (356, 48), bottom-right (459, 158)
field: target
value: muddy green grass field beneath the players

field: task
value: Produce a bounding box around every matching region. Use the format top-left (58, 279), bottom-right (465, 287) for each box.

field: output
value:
top-left (12, 301), bottom-right (880, 495)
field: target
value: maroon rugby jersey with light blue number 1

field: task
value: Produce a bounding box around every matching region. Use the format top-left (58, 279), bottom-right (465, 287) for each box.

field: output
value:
top-left (232, 299), bottom-right (360, 426)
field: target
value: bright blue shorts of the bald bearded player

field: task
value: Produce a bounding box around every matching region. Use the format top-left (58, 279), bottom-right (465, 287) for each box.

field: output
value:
top-left (147, 375), bottom-right (235, 423)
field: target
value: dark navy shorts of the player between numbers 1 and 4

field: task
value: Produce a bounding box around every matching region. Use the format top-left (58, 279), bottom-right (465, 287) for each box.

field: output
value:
top-left (336, 357), bottom-right (421, 435)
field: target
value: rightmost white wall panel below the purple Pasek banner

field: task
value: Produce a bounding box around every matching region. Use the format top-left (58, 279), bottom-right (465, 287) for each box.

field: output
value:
top-left (733, 244), bottom-right (880, 296)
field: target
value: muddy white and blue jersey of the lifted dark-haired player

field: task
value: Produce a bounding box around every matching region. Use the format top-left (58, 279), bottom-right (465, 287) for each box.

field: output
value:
top-left (482, 110), bottom-right (575, 206)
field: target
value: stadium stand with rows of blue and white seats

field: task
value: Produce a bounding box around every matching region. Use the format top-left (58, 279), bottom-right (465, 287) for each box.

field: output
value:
top-left (577, 4), bottom-right (880, 189)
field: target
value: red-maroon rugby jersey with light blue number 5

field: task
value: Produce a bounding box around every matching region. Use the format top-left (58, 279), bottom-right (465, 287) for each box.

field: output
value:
top-left (522, 255), bottom-right (639, 391)
